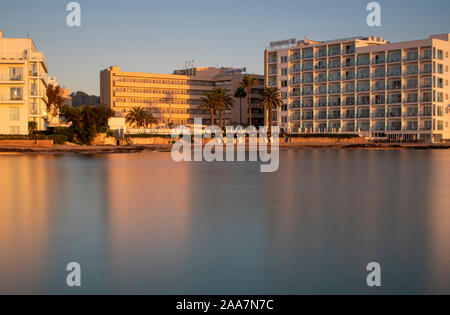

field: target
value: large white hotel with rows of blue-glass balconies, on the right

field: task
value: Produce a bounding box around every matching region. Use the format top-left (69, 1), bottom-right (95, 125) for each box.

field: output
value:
top-left (265, 34), bottom-right (450, 142)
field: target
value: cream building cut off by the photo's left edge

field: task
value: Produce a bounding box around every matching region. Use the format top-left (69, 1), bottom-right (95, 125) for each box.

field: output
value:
top-left (0, 31), bottom-right (48, 134)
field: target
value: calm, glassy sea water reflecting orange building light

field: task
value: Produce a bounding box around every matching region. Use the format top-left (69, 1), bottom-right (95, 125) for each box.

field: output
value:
top-left (0, 150), bottom-right (450, 294)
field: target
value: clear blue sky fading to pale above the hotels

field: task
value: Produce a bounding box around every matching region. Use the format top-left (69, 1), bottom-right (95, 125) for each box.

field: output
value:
top-left (0, 0), bottom-right (450, 94)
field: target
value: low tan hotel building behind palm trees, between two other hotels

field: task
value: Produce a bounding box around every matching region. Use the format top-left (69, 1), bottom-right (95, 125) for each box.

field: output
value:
top-left (100, 66), bottom-right (264, 127)
